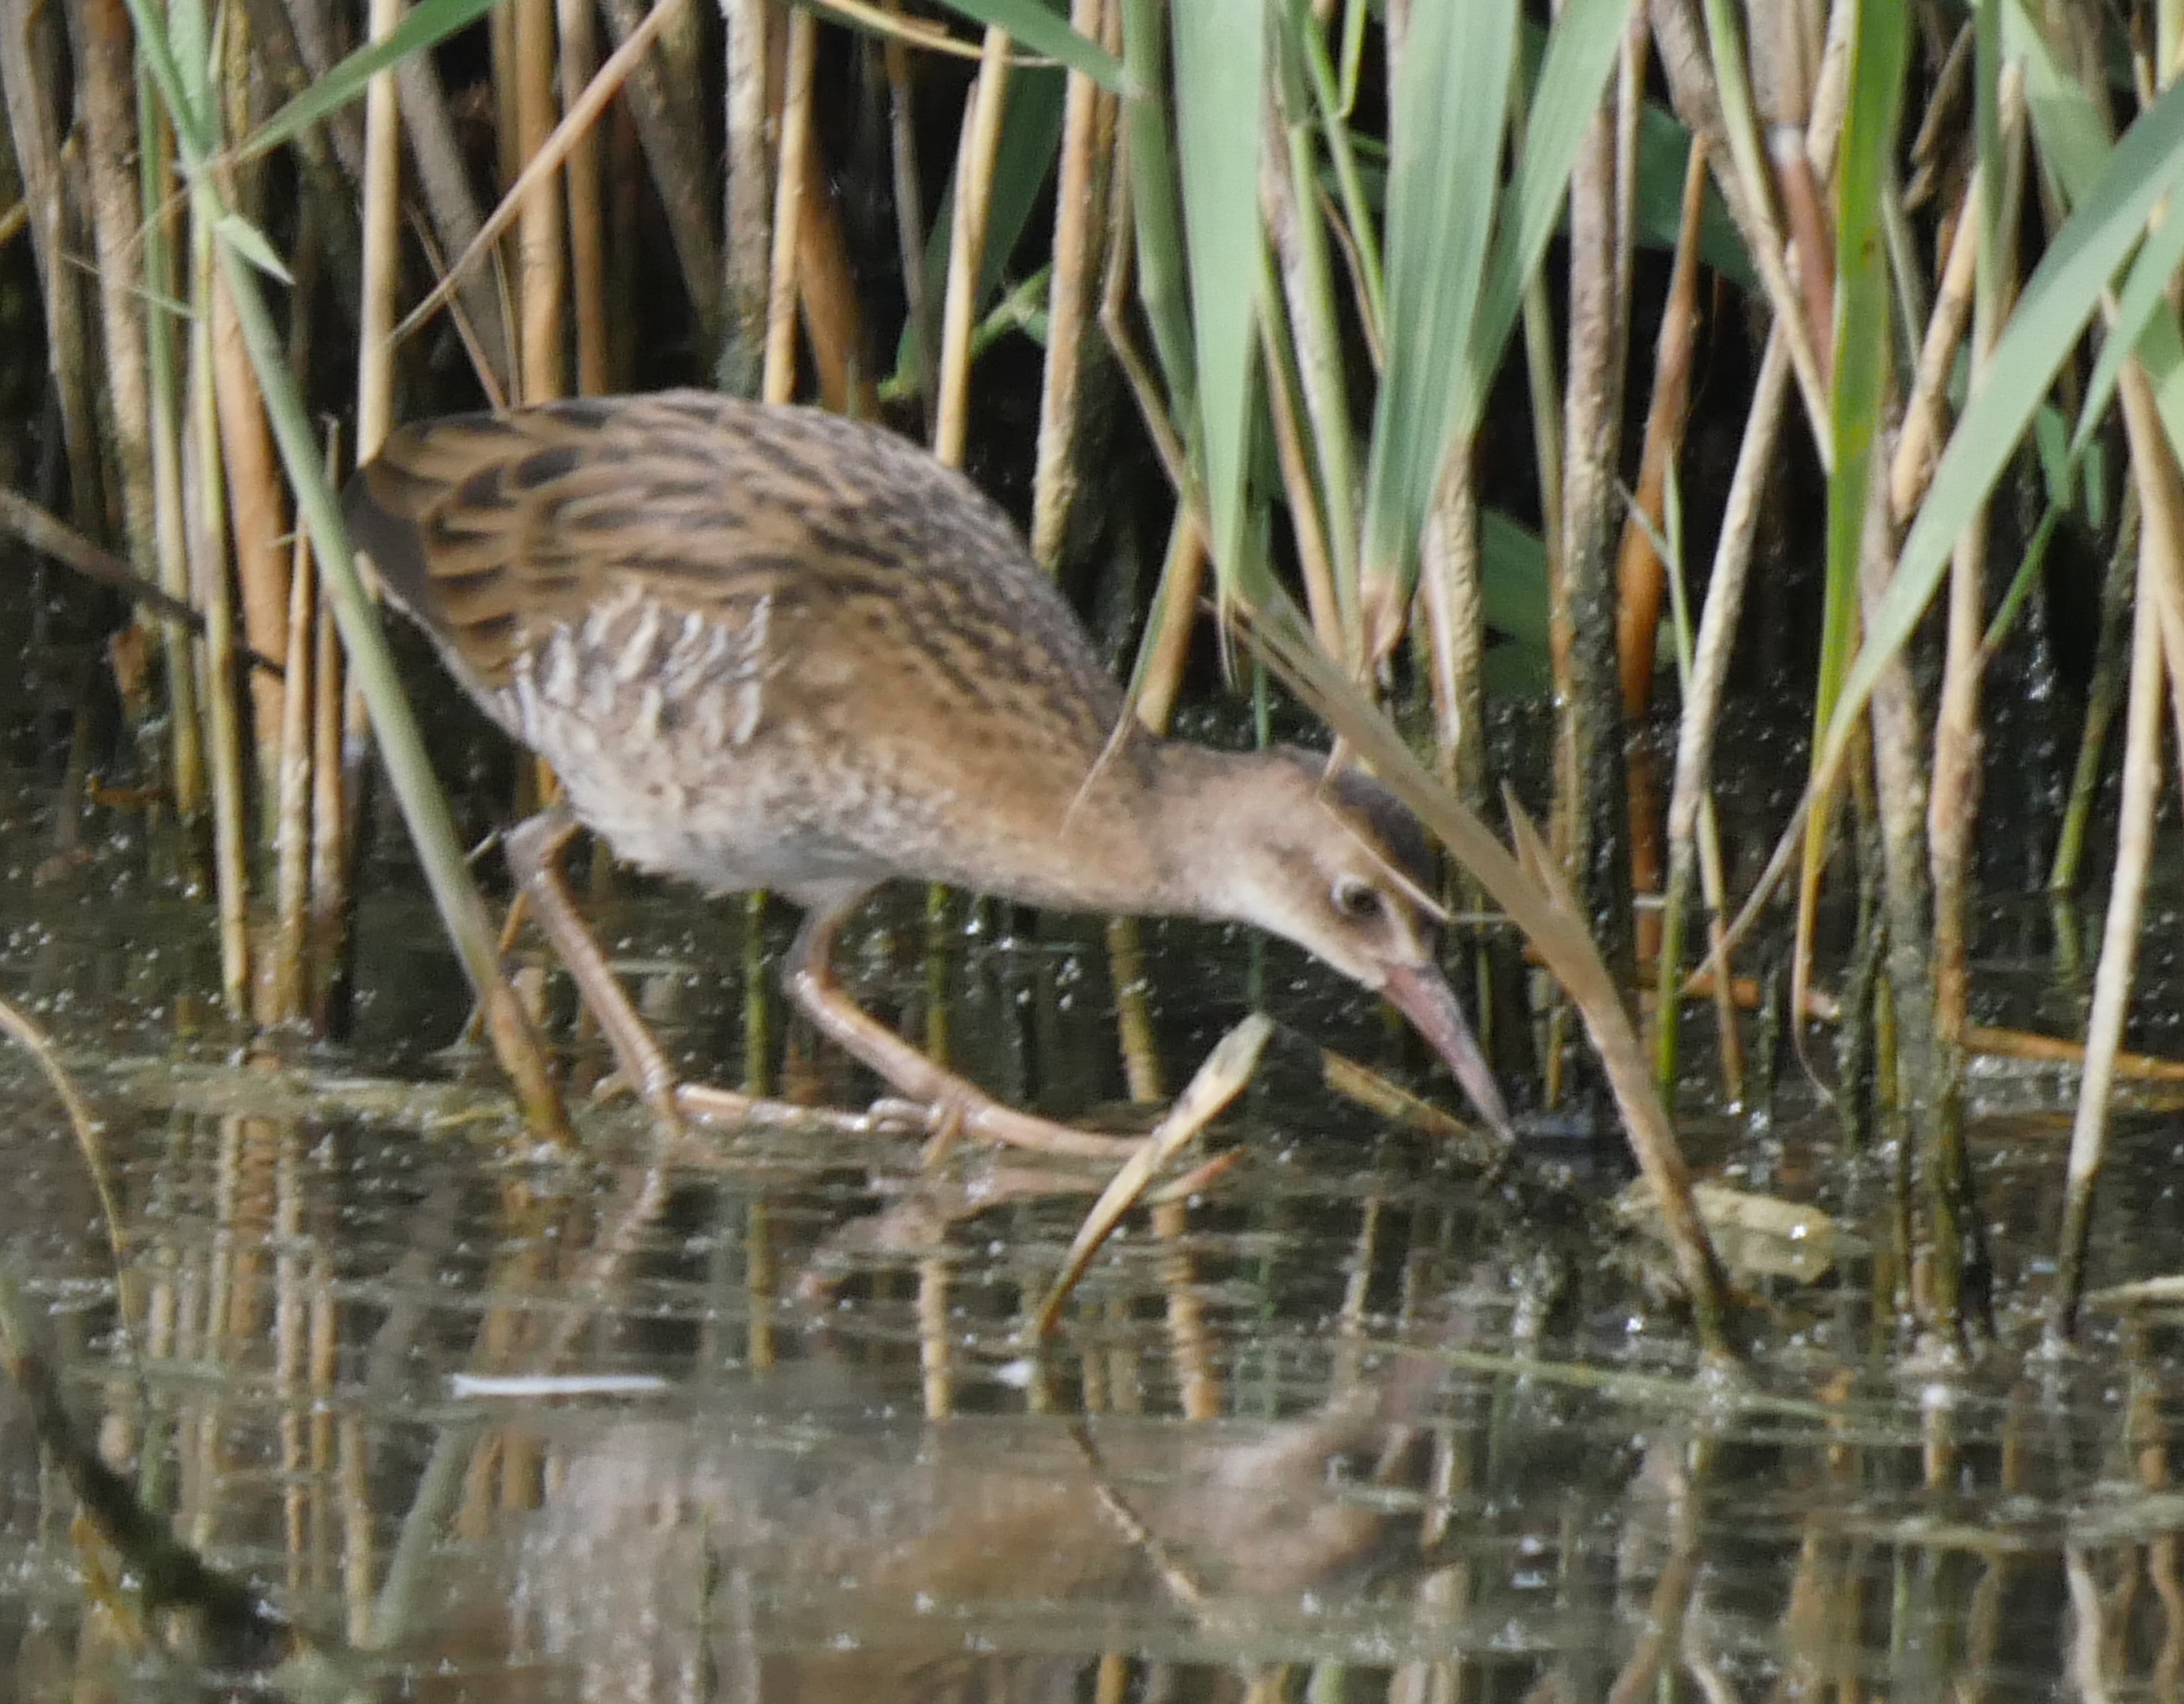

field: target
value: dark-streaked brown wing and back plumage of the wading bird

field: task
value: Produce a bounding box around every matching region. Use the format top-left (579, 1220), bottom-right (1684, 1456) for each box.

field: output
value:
top-left (347, 391), bottom-right (1120, 747)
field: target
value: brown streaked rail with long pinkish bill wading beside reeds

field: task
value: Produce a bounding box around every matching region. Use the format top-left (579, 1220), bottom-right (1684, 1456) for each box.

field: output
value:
top-left (343, 389), bottom-right (1509, 1156)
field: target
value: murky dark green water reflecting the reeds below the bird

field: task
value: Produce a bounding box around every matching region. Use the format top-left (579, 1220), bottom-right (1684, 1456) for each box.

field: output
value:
top-left (0, 791), bottom-right (2184, 1702)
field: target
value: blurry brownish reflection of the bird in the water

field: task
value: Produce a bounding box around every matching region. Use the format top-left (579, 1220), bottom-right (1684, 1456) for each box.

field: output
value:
top-left (426, 1370), bottom-right (1418, 1704)
